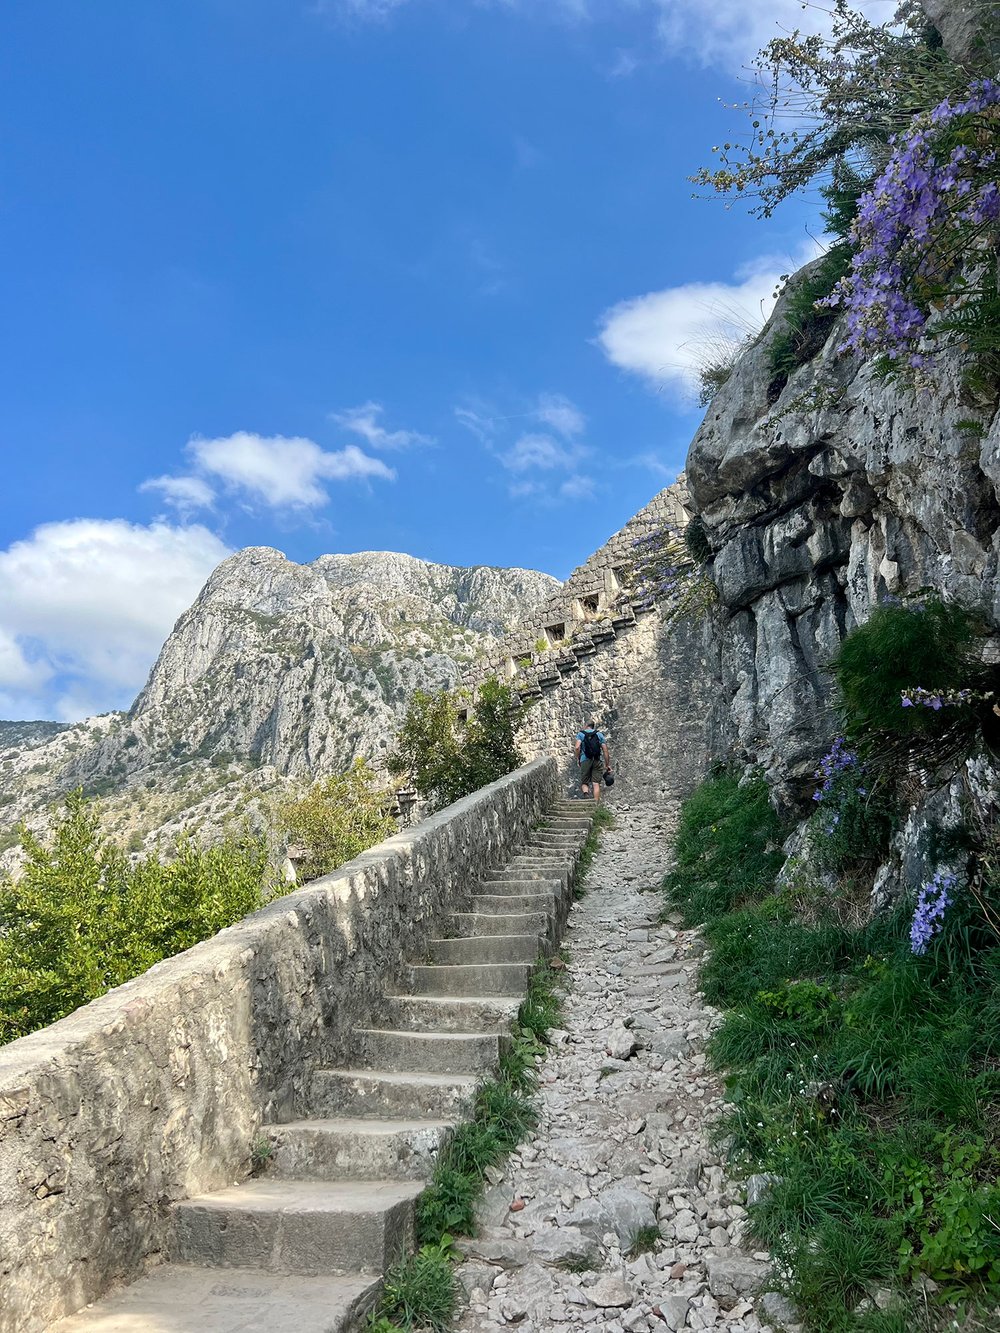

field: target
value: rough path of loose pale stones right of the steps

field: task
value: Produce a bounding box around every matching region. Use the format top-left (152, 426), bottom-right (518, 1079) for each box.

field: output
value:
top-left (459, 805), bottom-right (789, 1333)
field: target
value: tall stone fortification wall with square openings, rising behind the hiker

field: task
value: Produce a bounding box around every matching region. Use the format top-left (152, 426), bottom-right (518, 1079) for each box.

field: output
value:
top-left (465, 479), bottom-right (716, 801)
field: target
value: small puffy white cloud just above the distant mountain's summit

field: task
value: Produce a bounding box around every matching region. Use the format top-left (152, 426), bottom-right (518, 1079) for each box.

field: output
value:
top-left (188, 431), bottom-right (396, 509)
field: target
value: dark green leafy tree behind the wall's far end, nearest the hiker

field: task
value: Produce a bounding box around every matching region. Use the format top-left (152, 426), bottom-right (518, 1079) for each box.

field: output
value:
top-left (389, 677), bottom-right (524, 808)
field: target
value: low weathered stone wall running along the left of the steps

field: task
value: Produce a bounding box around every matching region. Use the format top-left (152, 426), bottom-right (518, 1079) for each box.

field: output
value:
top-left (0, 760), bottom-right (557, 1333)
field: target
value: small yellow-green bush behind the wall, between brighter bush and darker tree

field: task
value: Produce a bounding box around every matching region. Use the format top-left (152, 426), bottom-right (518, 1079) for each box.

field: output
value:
top-left (277, 758), bottom-right (396, 880)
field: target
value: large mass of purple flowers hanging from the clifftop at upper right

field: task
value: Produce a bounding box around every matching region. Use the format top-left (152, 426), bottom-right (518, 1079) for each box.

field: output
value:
top-left (823, 79), bottom-right (1000, 372)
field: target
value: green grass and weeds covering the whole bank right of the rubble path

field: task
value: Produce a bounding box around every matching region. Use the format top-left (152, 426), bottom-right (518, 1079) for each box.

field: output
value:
top-left (667, 777), bottom-right (1000, 1333)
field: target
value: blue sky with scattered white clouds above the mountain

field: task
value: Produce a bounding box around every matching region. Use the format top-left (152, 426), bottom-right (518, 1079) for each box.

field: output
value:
top-left (0, 0), bottom-right (832, 718)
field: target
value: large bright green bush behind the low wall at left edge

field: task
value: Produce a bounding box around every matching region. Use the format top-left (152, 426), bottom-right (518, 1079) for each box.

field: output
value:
top-left (0, 792), bottom-right (269, 1041)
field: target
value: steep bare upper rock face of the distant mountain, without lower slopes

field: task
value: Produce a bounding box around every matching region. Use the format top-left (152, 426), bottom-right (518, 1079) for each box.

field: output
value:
top-left (128, 548), bottom-right (557, 774)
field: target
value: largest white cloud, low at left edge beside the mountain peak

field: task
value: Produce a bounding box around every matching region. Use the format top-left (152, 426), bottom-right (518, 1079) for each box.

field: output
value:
top-left (0, 519), bottom-right (229, 721)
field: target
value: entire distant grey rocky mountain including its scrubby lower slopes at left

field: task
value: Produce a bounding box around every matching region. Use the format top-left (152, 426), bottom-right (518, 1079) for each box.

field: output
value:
top-left (0, 547), bottom-right (559, 845)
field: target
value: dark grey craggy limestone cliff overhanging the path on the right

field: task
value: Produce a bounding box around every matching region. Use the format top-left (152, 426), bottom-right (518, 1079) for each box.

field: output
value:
top-left (687, 277), bottom-right (1000, 794)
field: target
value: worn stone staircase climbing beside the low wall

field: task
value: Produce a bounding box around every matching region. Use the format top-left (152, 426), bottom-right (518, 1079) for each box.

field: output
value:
top-left (49, 801), bottom-right (593, 1333)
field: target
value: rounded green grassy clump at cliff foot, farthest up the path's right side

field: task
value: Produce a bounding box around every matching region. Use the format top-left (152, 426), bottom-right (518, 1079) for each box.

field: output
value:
top-left (664, 772), bottom-right (783, 925)
